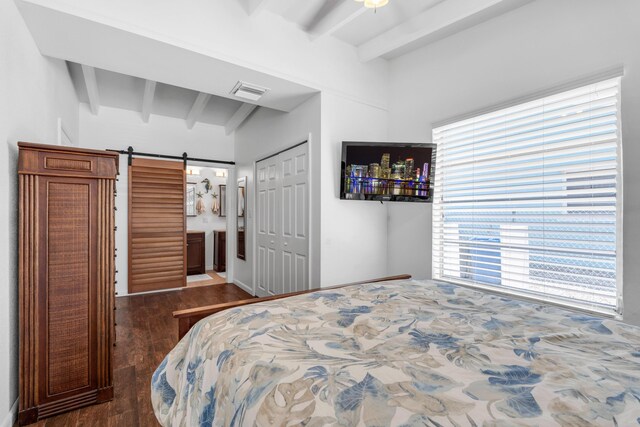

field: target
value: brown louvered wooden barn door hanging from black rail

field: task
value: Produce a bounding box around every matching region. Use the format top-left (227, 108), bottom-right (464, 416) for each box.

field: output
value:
top-left (129, 159), bottom-right (186, 293)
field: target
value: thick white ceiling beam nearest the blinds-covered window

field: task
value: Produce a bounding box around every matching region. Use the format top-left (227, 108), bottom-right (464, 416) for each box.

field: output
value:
top-left (358, 0), bottom-right (533, 62)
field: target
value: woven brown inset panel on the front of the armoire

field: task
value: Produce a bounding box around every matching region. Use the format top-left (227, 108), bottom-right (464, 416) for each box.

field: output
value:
top-left (40, 178), bottom-right (97, 397)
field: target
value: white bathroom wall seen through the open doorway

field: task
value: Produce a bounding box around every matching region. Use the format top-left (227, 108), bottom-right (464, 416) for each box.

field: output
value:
top-left (187, 166), bottom-right (228, 270)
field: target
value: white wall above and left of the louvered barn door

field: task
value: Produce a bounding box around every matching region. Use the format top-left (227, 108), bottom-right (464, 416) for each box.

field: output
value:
top-left (80, 104), bottom-right (234, 296)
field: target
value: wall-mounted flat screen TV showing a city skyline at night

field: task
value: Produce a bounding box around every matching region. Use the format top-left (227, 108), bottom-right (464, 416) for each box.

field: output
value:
top-left (340, 141), bottom-right (436, 203)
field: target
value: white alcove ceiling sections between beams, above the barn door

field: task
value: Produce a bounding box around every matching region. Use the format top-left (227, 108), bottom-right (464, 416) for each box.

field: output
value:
top-left (67, 62), bottom-right (243, 126)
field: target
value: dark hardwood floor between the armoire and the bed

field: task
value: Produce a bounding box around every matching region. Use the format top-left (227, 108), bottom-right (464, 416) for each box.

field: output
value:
top-left (26, 284), bottom-right (251, 427)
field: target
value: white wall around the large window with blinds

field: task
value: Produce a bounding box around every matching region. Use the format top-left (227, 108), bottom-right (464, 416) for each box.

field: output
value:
top-left (389, 0), bottom-right (640, 324)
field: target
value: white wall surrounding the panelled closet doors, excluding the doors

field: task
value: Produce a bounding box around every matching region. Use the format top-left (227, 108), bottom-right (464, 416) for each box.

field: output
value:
top-left (234, 94), bottom-right (321, 292)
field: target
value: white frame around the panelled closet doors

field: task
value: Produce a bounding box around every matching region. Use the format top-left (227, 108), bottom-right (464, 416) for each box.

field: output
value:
top-left (251, 140), bottom-right (315, 295)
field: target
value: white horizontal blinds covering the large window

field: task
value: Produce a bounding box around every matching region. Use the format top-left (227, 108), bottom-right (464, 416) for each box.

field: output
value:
top-left (433, 78), bottom-right (621, 312)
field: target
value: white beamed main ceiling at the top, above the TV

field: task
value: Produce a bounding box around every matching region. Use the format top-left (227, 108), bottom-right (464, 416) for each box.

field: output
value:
top-left (258, 0), bottom-right (533, 62)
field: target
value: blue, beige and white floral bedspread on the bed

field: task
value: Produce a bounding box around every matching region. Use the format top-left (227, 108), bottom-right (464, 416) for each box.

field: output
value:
top-left (151, 281), bottom-right (640, 427)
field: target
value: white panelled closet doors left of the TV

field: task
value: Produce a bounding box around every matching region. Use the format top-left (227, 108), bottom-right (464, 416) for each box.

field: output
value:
top-left (256, 144), bottom-right (309, 296)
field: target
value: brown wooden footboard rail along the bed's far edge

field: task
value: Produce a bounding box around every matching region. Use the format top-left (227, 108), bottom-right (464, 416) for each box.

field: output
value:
top-left (173, 274), bottom-right (411, 339)
